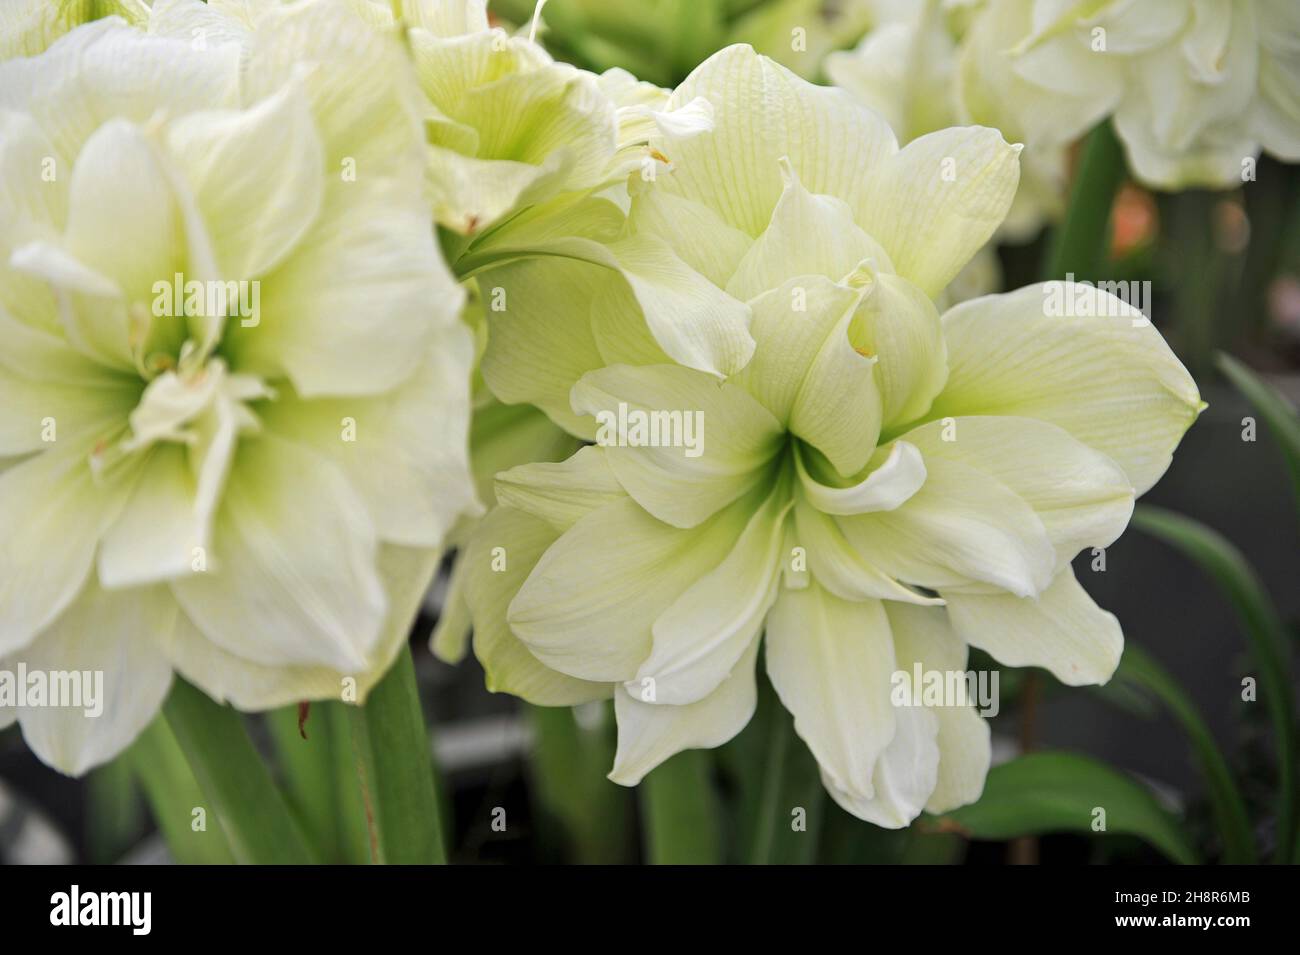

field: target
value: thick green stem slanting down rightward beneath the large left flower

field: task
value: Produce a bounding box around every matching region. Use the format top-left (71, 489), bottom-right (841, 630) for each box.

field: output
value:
top-left (163, 678), bottom-right (315, 864)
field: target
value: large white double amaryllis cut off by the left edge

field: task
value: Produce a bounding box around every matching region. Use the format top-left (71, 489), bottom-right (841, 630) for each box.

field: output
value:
top-left (0, 0), bottom-right (475, 773)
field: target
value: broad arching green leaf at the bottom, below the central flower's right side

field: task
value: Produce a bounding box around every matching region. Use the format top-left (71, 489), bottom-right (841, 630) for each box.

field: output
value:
top-left (941, 752), bottom-right (1199, 865)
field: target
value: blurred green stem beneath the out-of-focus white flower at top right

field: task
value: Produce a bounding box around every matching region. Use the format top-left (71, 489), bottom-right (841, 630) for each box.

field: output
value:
top-left (1044, 121), bottom-right (1125, 282)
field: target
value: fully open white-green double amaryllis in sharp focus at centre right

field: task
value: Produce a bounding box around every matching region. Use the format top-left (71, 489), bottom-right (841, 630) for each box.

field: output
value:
top-left (464, 47), bottom-right (1200, 826)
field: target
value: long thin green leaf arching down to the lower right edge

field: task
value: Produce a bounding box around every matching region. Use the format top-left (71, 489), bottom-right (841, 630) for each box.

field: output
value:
top-left (1132, 504), bottom-right (1297, 860)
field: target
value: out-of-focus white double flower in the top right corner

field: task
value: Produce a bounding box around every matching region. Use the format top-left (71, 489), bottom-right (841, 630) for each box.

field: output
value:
top-left (989, 0), bottom-right (1300, 188)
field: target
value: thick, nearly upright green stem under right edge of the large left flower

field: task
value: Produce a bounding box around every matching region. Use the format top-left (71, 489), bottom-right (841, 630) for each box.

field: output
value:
top-left (351, 647), bottom-right (447, 865)
